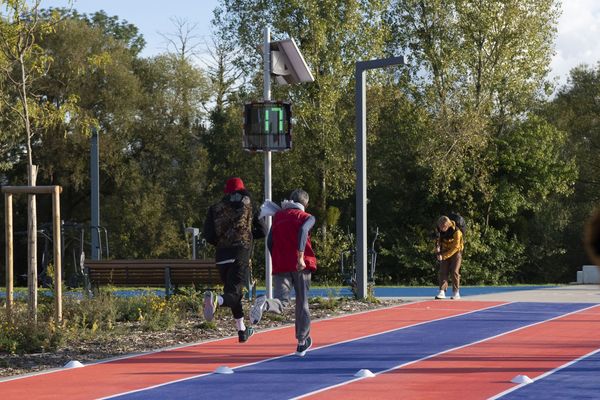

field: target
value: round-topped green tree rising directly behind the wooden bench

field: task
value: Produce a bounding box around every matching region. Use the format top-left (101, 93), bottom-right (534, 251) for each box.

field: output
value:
top-left (119, 54), bottom-right (208, 256)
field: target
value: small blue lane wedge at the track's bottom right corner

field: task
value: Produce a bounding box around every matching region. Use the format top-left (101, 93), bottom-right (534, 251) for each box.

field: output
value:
top-left (499, 352), bottom-right (600, 400)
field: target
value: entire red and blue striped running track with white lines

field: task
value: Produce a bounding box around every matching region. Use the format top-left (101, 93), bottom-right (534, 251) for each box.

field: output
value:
top-left (0, 300), bottom-right (600, 400)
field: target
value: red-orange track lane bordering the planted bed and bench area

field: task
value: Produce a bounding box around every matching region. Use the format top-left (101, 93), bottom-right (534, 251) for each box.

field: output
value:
top-left (0, 301), bottom-right (504, 400)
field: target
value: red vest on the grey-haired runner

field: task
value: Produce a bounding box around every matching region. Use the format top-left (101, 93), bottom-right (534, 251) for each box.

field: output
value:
top-left (271, 208), bottom-right (317, 274)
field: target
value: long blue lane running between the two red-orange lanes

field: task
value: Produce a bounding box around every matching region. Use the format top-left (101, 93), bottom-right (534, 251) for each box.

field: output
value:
top-left (114, 303), bottom-right (590, 400)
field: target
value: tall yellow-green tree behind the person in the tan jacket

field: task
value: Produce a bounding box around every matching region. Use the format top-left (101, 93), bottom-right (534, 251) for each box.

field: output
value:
top-left (364, 0), bottom-right (574, 283)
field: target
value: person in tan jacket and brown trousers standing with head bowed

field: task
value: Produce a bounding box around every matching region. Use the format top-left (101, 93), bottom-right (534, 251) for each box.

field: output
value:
top-left (435, 215), bottom-right (464, 299)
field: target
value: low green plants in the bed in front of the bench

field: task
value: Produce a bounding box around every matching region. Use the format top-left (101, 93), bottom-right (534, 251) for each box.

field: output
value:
top-left (0, 288), bottom-right (209, 354)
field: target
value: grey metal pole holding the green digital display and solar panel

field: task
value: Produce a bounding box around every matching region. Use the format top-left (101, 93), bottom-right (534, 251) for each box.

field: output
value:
top-left (263, 27), bottom-right (273, 299)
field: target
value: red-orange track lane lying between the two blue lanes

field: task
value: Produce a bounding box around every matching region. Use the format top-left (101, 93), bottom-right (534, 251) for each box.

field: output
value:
top-left (303, 306), bottom-right (600, 400)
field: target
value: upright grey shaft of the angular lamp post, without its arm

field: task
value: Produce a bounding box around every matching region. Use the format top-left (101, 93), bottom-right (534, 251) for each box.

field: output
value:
top-left (355, 63), bottom-right (367, 299)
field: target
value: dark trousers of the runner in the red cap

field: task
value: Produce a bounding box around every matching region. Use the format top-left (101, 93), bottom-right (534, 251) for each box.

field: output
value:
top-left (217, 248), bottom-right (250, 319)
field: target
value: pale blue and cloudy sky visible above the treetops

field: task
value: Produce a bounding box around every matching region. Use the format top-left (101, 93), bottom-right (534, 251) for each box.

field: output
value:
top-left (42, 0), bottom-right (600, 84)
